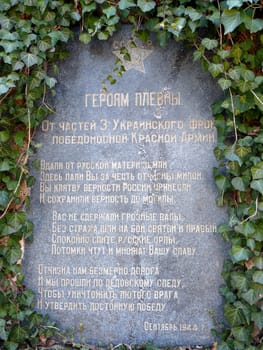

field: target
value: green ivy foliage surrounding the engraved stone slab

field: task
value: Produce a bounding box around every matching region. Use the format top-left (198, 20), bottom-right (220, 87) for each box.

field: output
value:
top-left (0, 0), bottom-right (263, 350)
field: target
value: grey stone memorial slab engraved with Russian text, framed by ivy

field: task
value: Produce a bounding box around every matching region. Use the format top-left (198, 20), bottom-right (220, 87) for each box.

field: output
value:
top-left (24, 29), bottom-right (224, 346)
